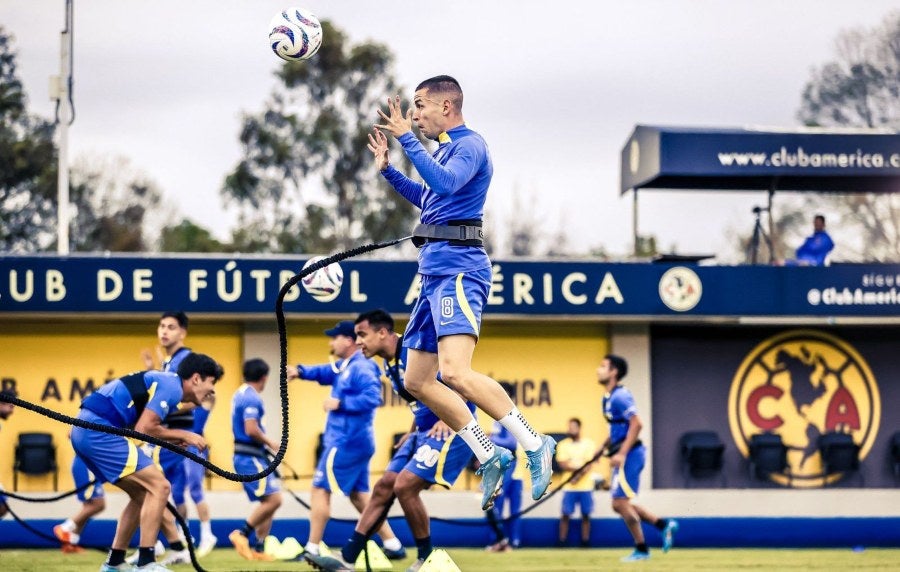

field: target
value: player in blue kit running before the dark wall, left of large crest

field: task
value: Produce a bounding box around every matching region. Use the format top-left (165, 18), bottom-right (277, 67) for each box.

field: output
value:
top-left (597, 354), bottom-right (678, 562)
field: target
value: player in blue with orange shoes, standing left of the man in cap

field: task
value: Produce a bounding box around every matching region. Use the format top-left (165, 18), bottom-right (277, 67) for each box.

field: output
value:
top-left (228, 358), bottom-right (281, 560)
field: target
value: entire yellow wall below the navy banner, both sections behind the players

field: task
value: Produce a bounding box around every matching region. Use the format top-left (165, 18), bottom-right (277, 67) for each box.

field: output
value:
top-left (0, 316), bottom-right (609, 491)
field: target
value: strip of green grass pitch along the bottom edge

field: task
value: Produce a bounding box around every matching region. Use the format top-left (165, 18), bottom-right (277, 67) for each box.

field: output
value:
top-left (0, 548), bottom-right (900, 572)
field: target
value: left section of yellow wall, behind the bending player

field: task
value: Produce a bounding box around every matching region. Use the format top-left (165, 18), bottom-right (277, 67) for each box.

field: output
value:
top-left (0, 318), bottom-right (242, 491)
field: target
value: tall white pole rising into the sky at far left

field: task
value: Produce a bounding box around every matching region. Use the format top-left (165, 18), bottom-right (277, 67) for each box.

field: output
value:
top-left (50, 0), bottom-right (75, 254)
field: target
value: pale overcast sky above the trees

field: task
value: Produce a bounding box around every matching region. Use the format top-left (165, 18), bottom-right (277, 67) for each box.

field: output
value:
top-left (0, 0), bottom-right (900, 260)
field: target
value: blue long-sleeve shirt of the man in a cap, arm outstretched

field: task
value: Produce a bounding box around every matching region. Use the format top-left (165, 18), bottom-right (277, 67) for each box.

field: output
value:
top-left (298, 350), bottom-right (381, 452)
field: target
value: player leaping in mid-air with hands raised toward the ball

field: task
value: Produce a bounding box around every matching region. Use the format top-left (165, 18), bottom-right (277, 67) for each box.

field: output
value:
top-left (368, 75), bottom-right (556, 510)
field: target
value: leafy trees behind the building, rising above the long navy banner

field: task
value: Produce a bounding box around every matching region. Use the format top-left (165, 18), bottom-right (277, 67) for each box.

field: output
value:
top-left (0, 11), bottom-right (900, 261)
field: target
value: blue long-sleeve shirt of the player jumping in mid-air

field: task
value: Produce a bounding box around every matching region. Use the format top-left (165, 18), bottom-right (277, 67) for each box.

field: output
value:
top-left (382, 125), bottom-right (494, 276)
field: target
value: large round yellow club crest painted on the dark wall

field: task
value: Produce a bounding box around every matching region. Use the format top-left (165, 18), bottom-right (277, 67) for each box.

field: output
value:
top-left (728, 330), bottom-right (881, 488)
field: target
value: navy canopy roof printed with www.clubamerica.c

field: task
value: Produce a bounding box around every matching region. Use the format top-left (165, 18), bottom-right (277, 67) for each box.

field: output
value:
top-left (620, 125), bottom-right (900, 193)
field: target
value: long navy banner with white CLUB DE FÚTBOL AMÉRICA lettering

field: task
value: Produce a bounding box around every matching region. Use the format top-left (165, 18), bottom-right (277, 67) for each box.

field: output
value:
top-left (0, 256), bottom-right (900, 318)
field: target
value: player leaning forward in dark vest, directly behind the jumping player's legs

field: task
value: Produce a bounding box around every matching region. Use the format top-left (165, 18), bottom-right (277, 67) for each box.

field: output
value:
top-left (307, 310), bottom-right (475, 572)
